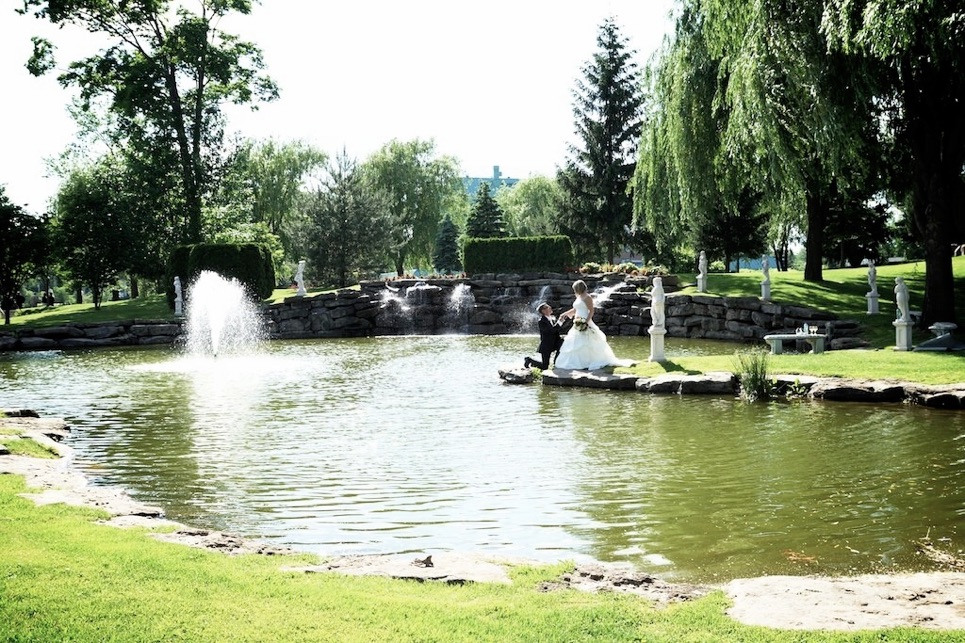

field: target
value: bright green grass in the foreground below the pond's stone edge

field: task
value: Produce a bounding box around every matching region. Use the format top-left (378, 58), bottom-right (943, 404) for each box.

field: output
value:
top-left (0, 475), bottom-right (965, 643)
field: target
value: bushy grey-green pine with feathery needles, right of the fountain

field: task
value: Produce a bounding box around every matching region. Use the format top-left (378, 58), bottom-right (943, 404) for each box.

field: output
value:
top-left (302, 152), bottom-right (391, 288)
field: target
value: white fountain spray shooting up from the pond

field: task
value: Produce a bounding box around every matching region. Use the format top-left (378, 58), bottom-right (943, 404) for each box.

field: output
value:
top-left (187, 270), bottom-right (264, 356)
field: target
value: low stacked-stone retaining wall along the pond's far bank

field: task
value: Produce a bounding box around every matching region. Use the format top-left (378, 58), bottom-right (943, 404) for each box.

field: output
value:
top-left (0, 273), bottom-right (860, 351)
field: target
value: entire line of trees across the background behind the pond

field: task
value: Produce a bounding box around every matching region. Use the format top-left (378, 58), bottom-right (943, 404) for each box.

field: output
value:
top-left (0, 0), bottom-right (965, 330)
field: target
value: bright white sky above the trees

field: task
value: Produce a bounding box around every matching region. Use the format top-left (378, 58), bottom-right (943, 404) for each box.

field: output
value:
top-left (0, 0), bottom-right (674, 212)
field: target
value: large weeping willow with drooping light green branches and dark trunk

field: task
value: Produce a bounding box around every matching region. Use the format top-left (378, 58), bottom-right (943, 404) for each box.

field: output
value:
top-left (634, 0), bottom-right (873, 281)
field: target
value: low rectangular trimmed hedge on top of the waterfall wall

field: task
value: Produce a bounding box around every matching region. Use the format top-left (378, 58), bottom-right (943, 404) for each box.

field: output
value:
top-left (463, 235), bottom-right (573, 275)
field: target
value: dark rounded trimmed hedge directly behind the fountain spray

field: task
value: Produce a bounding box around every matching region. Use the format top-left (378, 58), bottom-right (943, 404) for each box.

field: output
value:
top-left (167, 243), bottom-right (275, 308)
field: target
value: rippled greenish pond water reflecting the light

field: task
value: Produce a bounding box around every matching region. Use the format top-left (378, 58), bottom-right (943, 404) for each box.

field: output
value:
top-left (0, 336), bottom-right (965, 581)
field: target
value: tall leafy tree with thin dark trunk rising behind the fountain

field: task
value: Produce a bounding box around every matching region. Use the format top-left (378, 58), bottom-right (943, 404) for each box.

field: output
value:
top-left (19, 0), bottom-right (277, 241)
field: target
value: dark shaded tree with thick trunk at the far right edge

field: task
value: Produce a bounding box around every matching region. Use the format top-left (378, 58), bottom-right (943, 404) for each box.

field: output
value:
top-left (822, 0), bottom-right (965, 324)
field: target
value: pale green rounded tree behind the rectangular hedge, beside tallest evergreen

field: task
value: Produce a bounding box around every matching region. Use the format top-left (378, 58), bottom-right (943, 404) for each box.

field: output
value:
top-left (494, 176), bottom-right (563, 237)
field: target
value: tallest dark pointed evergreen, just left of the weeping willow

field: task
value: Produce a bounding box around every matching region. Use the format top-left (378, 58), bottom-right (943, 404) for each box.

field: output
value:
top-left (557, 17), bottom-right (643, 263)
